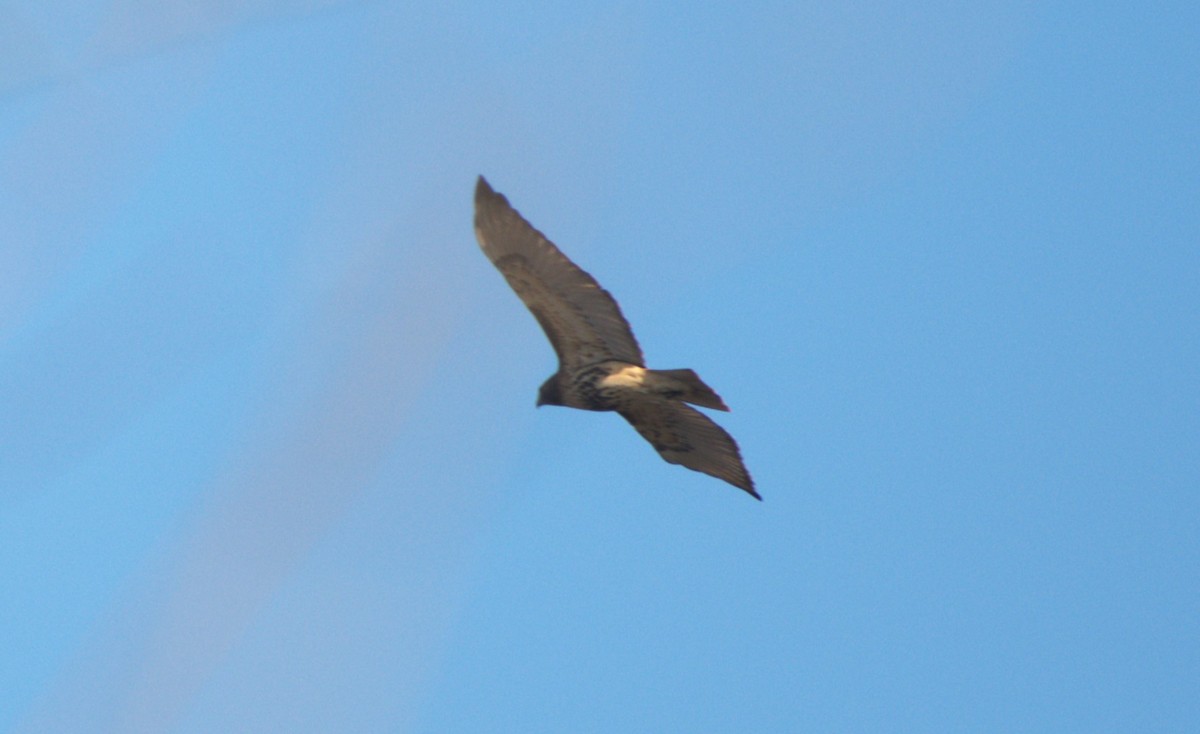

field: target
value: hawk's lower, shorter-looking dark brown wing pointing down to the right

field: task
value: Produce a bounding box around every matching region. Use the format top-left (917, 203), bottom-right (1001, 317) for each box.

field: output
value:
top-left (617, 393), bottom-right (762, 500)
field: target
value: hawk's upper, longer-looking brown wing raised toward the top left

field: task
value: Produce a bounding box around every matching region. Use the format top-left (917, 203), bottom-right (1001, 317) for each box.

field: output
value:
top-left (475, 176), bottom-right (644, 371)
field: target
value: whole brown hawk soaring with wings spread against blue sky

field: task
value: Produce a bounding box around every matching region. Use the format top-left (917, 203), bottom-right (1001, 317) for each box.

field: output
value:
top-left (475, 176), bottom-right (762, 500)
